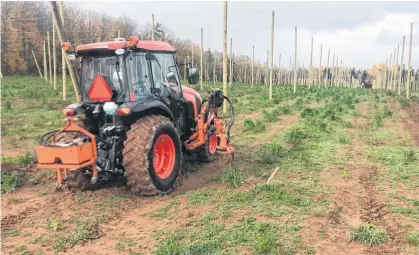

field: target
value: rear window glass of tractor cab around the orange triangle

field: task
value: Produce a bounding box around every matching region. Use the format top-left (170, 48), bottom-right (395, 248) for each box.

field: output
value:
top-left (81, 56), bottom-right (126, 101)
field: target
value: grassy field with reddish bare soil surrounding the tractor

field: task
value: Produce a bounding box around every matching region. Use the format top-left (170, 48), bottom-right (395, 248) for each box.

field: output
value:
top-left (1, 77), bottom-right (419, 255)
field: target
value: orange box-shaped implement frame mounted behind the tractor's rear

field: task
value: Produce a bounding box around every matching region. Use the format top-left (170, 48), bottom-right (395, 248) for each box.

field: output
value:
top-left (36, 118), bottom-right (97, 186)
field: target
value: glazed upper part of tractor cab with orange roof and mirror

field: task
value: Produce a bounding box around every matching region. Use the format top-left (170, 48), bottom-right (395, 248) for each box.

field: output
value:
top-left (67, 36), bottom-right (198, 102)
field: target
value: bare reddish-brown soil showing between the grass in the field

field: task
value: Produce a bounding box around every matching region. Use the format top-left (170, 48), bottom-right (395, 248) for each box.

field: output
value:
top-left (1, 102), bottom-right (419, 255)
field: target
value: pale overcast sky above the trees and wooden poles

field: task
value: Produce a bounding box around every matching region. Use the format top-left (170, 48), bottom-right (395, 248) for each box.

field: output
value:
top-left (76, 1), bottom-right (419, 68)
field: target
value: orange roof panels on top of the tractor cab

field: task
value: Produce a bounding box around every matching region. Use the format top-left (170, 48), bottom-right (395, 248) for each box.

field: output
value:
top-left (76, 40), bottom-right (175, 53)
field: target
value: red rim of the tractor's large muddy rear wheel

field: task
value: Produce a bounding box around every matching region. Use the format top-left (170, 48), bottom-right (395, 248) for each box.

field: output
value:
top-left (153, 134), bottom-right (176, 179)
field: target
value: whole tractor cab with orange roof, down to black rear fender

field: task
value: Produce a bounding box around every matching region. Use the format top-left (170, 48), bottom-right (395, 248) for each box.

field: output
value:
top-left (63, 36), bottom-right (202, 135)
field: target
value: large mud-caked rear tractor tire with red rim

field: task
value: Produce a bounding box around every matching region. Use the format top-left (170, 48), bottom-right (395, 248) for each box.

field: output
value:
top-left (123, 115), bottom-right (182, 196)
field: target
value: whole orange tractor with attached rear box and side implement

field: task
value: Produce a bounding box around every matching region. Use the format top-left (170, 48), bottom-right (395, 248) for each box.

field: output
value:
top-left (36, 36), bottom-right (234, 195)
